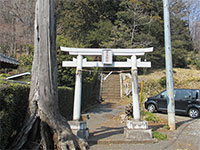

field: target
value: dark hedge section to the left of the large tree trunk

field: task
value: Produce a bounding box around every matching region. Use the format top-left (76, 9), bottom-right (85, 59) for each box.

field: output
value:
top-left (0, 84), bottom-right (29, 149)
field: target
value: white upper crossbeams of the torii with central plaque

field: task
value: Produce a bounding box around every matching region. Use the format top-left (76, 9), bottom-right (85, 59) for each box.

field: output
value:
top-left (61, 47), bottom-right (153, 68)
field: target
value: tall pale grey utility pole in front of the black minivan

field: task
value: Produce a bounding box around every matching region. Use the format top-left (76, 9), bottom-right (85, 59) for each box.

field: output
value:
top-left (163, 0), bottom-right (176, 130)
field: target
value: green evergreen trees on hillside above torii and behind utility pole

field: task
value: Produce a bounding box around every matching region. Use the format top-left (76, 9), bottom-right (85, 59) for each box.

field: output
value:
top-left (57, 0), bottom-right (193, 68)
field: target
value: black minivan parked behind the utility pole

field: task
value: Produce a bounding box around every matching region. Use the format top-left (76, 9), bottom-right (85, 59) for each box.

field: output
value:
top-left (145, 89), bottom-right (200, 118)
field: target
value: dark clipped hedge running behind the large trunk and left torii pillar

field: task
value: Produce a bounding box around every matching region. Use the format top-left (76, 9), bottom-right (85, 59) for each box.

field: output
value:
top-left (0, 75), bottom-right (98, 149)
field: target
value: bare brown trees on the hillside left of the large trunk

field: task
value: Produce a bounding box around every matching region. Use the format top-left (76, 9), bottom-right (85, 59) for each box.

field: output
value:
top-left (0, 0), bottom-right (35, 55)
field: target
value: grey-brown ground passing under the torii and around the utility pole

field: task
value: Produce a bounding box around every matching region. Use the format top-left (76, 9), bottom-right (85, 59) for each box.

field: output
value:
top-left (87, 103), bottom-right (200, 150)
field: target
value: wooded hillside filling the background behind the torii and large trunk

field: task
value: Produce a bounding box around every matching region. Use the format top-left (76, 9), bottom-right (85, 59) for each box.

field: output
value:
top-left (0, 0), bottom-right (200, 87)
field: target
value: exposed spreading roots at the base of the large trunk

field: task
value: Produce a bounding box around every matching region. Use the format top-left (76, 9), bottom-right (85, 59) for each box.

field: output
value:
top-left (9, 113), bottom-right (89, 150)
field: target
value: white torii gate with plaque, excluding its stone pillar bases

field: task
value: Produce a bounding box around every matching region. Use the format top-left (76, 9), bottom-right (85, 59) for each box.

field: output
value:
top-left (61, 47), bottom-right (153, 120)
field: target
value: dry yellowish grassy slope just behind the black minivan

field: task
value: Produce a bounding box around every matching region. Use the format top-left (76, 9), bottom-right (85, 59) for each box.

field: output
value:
top-left (139, 68), bottom-right (200, 102)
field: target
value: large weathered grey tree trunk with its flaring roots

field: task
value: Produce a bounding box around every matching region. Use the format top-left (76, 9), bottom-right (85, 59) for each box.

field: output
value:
top-left (11, 0), bottom-right (87, 150)
